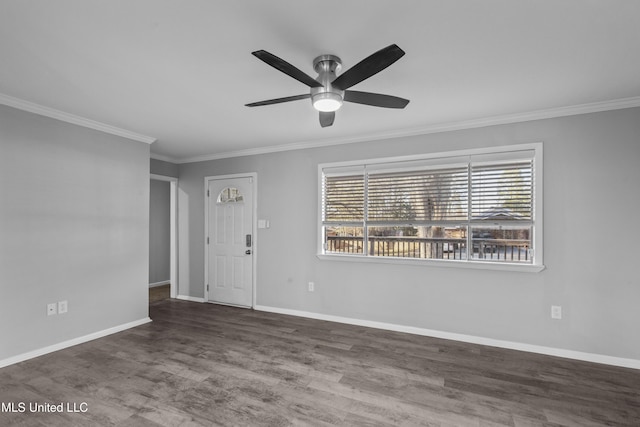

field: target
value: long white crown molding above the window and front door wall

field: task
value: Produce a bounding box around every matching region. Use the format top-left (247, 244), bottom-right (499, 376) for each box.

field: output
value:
top-left (172, 96), bottom-right (640, 163)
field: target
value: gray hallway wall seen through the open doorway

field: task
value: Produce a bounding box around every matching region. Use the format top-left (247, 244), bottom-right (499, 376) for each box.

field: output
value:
top-left (149, 179), bottom-right (171, 284)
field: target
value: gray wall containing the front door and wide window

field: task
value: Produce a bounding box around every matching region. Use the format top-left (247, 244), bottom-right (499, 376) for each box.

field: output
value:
top-left (179, 108), bottom-right (640, 359)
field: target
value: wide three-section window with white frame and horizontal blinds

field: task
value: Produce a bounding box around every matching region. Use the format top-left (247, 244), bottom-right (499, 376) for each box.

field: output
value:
top-left (319, 144), bottom-right (542, 270)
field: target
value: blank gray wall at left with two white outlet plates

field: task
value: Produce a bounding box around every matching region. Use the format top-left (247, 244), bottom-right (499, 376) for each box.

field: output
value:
top-left (0, 105), bottom-right (149, 360)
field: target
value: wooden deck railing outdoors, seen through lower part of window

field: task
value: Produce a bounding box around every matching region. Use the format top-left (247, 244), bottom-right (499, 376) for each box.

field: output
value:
top-left (325, 236), bottom-right (531, 263)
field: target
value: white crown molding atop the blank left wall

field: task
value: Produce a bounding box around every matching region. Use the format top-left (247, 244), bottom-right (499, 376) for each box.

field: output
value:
top-left (0, 93), bottom-right (156, 144)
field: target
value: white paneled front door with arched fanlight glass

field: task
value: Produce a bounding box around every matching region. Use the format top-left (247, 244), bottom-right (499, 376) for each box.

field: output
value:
top-left (205, 176), bottom-right (255, 307)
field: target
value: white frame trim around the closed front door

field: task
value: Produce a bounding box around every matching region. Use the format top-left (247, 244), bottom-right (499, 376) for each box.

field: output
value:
top-left (203, 172), bottom-right (258, 309)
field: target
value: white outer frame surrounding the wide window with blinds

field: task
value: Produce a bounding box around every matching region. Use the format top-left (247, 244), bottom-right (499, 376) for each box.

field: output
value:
top-left (316, 142), bottom-right (545, 272)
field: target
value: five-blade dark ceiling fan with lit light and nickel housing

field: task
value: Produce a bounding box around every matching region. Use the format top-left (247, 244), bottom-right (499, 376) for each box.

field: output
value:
top-left (246, 44), bottom-right (409, 127)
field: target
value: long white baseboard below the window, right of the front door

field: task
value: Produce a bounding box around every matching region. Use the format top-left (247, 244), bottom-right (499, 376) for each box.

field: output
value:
top-left (255, 305), bottom-right (640, 369)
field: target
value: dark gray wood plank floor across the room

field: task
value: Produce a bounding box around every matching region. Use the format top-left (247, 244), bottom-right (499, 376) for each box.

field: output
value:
top-left (0, 299), bottom-right (640, 427)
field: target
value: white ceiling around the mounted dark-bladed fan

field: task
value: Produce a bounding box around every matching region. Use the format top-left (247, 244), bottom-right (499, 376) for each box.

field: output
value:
top-left (0, 0), bottom-right (640, 162)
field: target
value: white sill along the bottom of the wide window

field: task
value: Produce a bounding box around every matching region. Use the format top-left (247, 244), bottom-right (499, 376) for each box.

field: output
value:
top-left (317, 254), bottom-right (545, 273)
